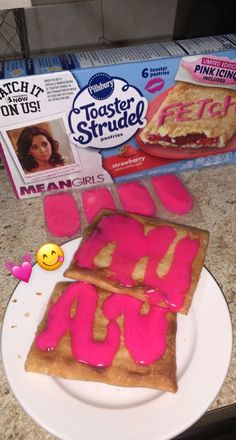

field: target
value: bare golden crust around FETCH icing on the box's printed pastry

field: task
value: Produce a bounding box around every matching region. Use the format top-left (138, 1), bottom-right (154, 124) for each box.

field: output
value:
top-left (140, 82), bottom-right (236, 148)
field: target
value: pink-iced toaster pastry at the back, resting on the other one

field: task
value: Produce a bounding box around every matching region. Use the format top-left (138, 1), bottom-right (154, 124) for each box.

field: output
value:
top-left (64, 212), bottom-right (208, 314)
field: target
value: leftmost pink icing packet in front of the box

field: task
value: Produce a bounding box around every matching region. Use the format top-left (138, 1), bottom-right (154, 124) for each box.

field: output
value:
top-left (43, 193), bottom-right (81, 237)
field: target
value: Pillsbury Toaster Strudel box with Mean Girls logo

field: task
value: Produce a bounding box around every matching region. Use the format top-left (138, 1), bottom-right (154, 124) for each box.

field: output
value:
top-left (0, 34), bottom-right (236, 198)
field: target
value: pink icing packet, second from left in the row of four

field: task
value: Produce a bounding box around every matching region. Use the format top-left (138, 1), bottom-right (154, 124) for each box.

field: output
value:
top-left (82, 188), bottom-right (116, 223)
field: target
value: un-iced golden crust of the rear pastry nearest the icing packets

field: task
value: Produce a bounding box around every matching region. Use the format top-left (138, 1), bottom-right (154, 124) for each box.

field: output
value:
top-left (64, 210), bottom-right (209, 314)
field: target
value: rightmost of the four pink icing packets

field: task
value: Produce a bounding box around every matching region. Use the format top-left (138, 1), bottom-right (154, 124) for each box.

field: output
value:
top-left (152, 174), bottom-right (193, 215)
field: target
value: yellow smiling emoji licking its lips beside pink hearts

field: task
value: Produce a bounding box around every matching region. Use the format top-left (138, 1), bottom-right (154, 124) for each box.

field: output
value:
top-left (36, 243), bottom-right (64, 270)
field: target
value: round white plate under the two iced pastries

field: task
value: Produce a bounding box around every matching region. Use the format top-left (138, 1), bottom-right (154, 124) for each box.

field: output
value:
top-left (2, 239), bottom-right (232, 440)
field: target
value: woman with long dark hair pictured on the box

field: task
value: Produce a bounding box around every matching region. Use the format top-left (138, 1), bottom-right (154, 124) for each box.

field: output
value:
top-left (17, 126), bottom-right (64, 173)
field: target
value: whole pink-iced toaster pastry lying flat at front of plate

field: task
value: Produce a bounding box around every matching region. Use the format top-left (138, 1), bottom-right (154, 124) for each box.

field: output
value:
top-left (25, 282), bottom-right (177, 392)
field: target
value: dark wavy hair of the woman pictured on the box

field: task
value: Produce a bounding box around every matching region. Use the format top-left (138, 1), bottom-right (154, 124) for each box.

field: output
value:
top-left (16, 126), bottom-right (64, 171)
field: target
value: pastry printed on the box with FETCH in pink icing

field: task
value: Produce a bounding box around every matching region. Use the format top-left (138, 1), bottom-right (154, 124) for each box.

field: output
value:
top-left (140, 82), bottom-right (236, 148)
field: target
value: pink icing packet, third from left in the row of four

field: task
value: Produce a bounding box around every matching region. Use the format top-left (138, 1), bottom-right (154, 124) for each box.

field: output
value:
top-left (117, 182), bottom-right (156, 215)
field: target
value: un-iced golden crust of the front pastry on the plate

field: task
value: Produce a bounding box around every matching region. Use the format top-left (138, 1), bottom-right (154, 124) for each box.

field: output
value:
top-left (25, 282), bottom-right (177, 392)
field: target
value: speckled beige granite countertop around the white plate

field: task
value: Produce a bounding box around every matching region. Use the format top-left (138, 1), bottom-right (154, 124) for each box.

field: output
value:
top-left (0, 164), bottom-right (236, 440)
